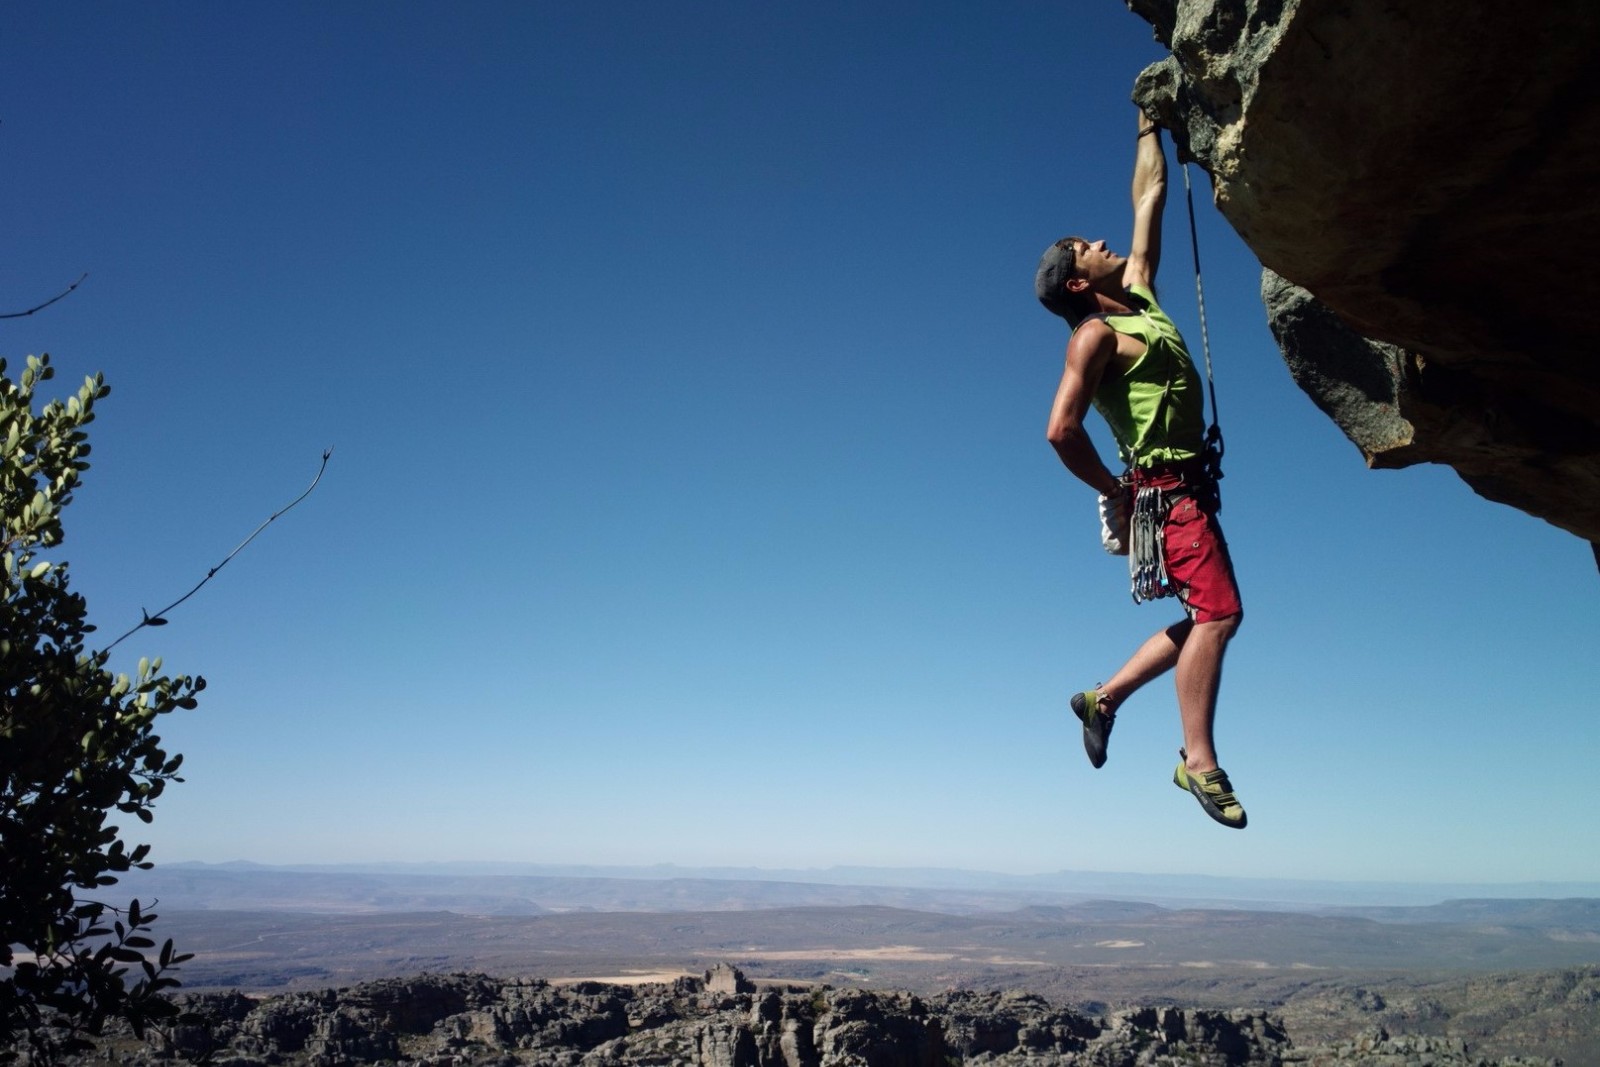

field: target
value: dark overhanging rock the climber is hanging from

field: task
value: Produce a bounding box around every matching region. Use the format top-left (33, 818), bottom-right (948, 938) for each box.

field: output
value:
top-left (1128, 0), bottom-right (1600, 542)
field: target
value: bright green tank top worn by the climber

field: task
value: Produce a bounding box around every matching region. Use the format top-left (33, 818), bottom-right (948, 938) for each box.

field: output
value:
top-left (1094, 285), bottom-right (1205, 467)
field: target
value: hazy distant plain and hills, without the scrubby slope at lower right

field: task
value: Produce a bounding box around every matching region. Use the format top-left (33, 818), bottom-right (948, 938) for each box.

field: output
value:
top-left (112, 864), bottom-right (1600, 989)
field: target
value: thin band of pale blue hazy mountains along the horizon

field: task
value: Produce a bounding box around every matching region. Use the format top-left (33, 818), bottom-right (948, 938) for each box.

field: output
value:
top-left (123, 862), bottom-right (1600, 915)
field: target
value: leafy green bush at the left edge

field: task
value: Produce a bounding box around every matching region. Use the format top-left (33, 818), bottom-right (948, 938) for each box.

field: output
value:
top-left (0, 355), bottom-right (205, 1062)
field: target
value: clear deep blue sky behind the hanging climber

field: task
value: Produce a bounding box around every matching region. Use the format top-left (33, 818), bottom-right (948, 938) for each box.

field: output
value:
top-left (0, 0), bottom-right (1600, 881)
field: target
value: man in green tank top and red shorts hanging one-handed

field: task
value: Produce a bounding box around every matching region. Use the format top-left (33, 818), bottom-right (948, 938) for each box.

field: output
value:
top-left (1034, 112), bottom-right (1245, 829)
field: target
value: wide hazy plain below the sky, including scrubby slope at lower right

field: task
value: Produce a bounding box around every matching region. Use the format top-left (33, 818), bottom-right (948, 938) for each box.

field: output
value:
top-left (96, 864), bottom-right (1600, 1064)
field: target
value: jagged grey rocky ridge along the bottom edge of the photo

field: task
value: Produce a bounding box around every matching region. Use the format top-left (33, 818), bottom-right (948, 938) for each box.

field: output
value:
top-left (96, 968), bottom-right (1552, 1067)
